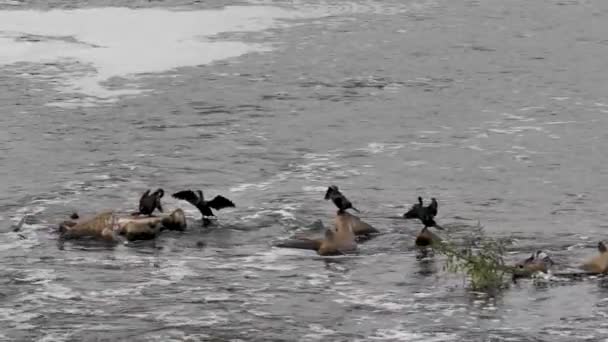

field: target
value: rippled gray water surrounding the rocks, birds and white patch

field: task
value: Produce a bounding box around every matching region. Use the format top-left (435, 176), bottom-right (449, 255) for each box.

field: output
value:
top-left (0, 0), bottom-right (608, 341)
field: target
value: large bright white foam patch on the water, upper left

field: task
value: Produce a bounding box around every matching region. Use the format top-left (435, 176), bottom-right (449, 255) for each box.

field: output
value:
top-left (0, 6), bottom-right (301, 106)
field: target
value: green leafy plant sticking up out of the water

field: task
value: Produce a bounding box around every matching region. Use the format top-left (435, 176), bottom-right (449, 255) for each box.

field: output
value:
top-left (433, 226), bottom-right (513, 292)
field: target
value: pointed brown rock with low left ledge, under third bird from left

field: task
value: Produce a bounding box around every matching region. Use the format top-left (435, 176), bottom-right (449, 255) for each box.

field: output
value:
top-left (276, 212), bottom-right (361, 256)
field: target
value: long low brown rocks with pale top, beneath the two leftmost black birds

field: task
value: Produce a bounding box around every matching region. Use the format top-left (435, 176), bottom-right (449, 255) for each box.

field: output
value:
top-left (59, 209), bottom-right (186, 241)
